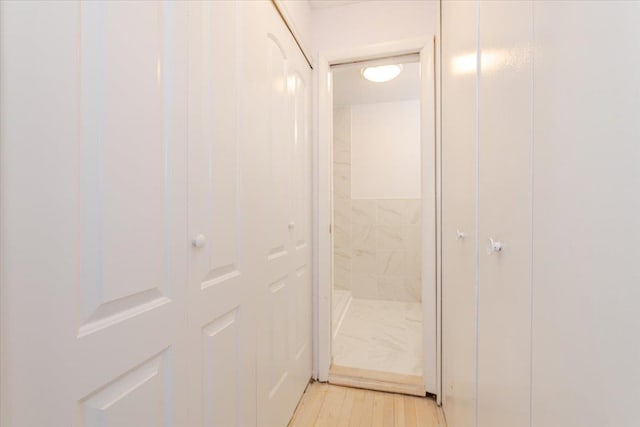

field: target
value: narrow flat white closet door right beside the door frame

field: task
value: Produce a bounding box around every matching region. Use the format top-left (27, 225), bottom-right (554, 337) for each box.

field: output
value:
top-left (442, 1), bottom-right (477, 427)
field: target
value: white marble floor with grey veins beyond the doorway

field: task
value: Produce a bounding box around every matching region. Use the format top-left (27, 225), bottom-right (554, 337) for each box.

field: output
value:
top-left (333, 298), bottom-right (422, 376)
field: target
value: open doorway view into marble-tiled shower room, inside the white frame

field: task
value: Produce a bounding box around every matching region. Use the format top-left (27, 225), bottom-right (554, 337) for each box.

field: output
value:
top-left (330, 54), bottom-right (425, 395)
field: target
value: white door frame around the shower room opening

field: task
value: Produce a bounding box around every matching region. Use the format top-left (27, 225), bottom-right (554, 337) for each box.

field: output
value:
top-left (314, 37), bottom-right (442, 403)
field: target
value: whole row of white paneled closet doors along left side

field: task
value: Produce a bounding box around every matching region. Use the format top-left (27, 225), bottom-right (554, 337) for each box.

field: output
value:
top-left (0, 1), bottom-right (311, 427)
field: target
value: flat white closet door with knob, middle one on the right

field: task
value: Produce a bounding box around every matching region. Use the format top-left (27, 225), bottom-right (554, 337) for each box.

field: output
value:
top-left (477, 1), bottom-right (532, 427)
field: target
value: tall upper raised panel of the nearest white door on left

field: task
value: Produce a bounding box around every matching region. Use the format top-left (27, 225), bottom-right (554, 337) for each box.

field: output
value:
top-left (79, 2), bottom-right (171, 336)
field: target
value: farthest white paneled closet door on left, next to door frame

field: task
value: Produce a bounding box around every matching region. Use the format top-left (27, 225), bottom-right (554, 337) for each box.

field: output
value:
top-left (242, 1), bottom-right (311, 426)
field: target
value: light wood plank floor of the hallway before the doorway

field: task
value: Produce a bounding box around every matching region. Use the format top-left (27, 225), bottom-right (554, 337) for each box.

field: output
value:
top-left (289, 382), bottom-right (446, 427)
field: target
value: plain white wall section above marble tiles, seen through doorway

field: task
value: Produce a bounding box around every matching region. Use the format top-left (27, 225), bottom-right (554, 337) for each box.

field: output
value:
top-left (351, 100), bottom-right (420, 199)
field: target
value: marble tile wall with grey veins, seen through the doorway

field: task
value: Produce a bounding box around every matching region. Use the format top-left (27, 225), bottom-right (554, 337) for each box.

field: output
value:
top-left (333, 107), bottom-right (422, 302)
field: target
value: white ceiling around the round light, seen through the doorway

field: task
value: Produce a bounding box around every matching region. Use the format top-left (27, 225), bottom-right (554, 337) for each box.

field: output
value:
top-left (333, 62), bottom-right (420, 105)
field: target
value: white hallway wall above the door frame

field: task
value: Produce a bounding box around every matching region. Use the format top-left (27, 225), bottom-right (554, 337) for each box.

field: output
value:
top-left (312, 0), bottom-right (439, 52)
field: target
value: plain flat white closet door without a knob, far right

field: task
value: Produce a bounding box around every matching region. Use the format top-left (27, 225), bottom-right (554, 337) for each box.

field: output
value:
top-left (532, 1), bottom-right (640, 427)
